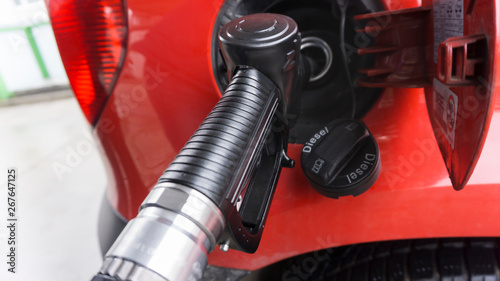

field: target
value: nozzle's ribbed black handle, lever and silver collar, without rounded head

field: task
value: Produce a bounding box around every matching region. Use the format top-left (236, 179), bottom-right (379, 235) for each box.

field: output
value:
top-left (96, 67), bottom-right (287, 281)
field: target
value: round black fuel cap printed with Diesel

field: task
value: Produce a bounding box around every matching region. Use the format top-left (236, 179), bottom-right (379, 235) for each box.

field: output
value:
top-left (301, 119), bottom-right (380, 198)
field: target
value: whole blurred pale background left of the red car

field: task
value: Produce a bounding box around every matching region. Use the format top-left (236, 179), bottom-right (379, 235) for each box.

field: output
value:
top-left (0, 0), bottom-right (106, 281)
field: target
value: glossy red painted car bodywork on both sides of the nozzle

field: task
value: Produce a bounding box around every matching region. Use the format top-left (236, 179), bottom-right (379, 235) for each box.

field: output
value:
top-left (90, 0), bottom-right (500, 269)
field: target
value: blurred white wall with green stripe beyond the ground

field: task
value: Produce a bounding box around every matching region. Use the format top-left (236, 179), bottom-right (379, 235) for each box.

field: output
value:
top-left (0, 0), bottom-right (68, 96)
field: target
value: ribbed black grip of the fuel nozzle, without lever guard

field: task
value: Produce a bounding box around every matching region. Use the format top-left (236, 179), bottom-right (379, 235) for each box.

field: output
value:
top-left (159, 68), bottom-right (279, 209)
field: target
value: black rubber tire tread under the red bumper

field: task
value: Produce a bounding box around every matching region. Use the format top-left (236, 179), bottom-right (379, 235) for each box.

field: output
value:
top-left (280, 238), bottom-right (500, 281)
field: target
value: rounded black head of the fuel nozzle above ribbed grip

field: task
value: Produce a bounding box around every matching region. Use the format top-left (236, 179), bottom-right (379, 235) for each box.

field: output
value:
top-left (219, 13), bottom-right (310, 126)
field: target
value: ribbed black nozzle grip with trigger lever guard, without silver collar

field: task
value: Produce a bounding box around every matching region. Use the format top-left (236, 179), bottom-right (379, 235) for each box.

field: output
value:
top-left (150, 67), bottom-right (287, 252)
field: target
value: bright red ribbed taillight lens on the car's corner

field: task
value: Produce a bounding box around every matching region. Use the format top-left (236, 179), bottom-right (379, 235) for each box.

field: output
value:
top-left (48, 0), bottom-right (127, 124)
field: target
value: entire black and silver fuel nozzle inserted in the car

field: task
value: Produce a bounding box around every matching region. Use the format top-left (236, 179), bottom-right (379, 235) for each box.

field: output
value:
top-left (95, 14), bottom-right (308, 281)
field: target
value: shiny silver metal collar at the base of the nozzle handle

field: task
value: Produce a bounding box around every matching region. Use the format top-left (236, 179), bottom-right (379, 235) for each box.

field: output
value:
top-left (101, 183), bottom-right (225, 281)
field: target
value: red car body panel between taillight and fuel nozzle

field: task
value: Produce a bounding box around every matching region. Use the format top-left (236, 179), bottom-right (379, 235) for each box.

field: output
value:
top-left (97, 0), bottom-right (224, 219)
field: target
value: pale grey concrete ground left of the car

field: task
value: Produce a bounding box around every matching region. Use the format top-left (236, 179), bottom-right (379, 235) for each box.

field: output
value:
top-left (0, 93), bottom-right (106, 281)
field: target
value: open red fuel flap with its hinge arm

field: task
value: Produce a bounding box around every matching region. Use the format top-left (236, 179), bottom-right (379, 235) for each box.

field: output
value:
top-left (355, 0), bottom-right (500, 190)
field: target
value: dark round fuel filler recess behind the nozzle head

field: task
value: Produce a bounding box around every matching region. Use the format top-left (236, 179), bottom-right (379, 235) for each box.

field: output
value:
top-left (211, 0), bottom-right (383, 144)
